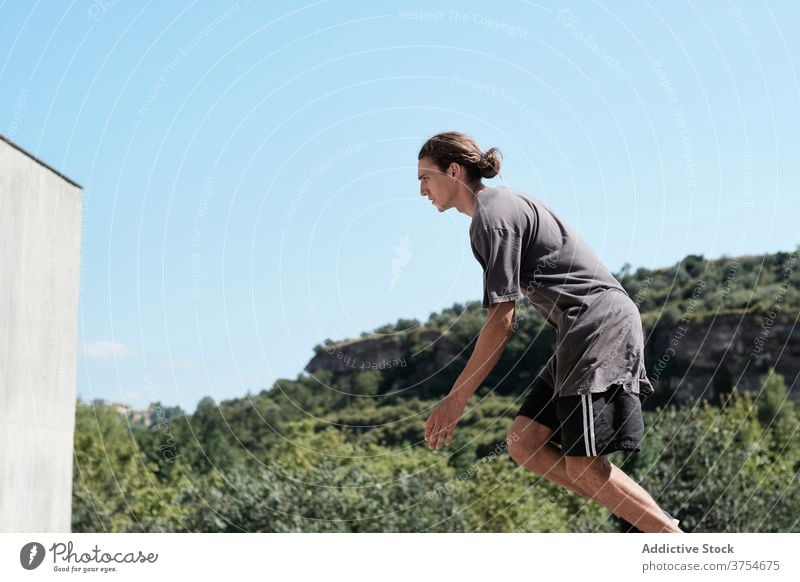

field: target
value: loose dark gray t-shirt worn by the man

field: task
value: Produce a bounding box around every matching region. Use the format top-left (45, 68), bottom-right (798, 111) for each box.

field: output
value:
top-left (469, 187), bottom-right (653, 397)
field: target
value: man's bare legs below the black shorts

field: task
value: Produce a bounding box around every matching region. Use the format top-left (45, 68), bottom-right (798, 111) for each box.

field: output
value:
top-left (508, 416), bottom-right (683, 533)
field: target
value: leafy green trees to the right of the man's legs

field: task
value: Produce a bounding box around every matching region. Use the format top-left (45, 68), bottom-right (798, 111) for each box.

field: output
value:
top-left (628, 392), bottom-right (800, 532)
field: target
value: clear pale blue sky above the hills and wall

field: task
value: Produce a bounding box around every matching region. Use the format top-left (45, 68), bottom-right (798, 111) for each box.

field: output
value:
top-left (0, 0), bottom-right (800, 418)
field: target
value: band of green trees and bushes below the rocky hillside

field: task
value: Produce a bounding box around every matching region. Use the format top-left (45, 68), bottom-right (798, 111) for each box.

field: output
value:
top-left (73, 371), bottom-right (800, 532)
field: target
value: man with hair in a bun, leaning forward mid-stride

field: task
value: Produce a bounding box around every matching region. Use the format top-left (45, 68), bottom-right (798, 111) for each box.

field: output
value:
top-left (417, 132), bottom-right (681, 533)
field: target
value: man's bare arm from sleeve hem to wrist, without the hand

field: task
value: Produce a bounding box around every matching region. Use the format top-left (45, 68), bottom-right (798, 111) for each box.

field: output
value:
top-left (448, 301), bottom-right (516, 402)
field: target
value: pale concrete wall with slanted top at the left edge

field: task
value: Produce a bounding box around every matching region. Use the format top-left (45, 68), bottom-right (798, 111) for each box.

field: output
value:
top-left (0, 136), bottom-right (81, 532)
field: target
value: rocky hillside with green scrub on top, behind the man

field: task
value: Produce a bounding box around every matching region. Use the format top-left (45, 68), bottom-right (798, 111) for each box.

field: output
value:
top-left (305, 247), bottom-right (800, 407)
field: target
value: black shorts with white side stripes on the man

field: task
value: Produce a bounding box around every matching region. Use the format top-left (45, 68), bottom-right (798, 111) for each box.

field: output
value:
top-left (517, 377), bottom-right (644, 457)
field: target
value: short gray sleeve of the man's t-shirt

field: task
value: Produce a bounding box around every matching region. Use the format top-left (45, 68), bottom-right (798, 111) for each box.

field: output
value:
top-left (472, 228), bottom-right (523, 308)
